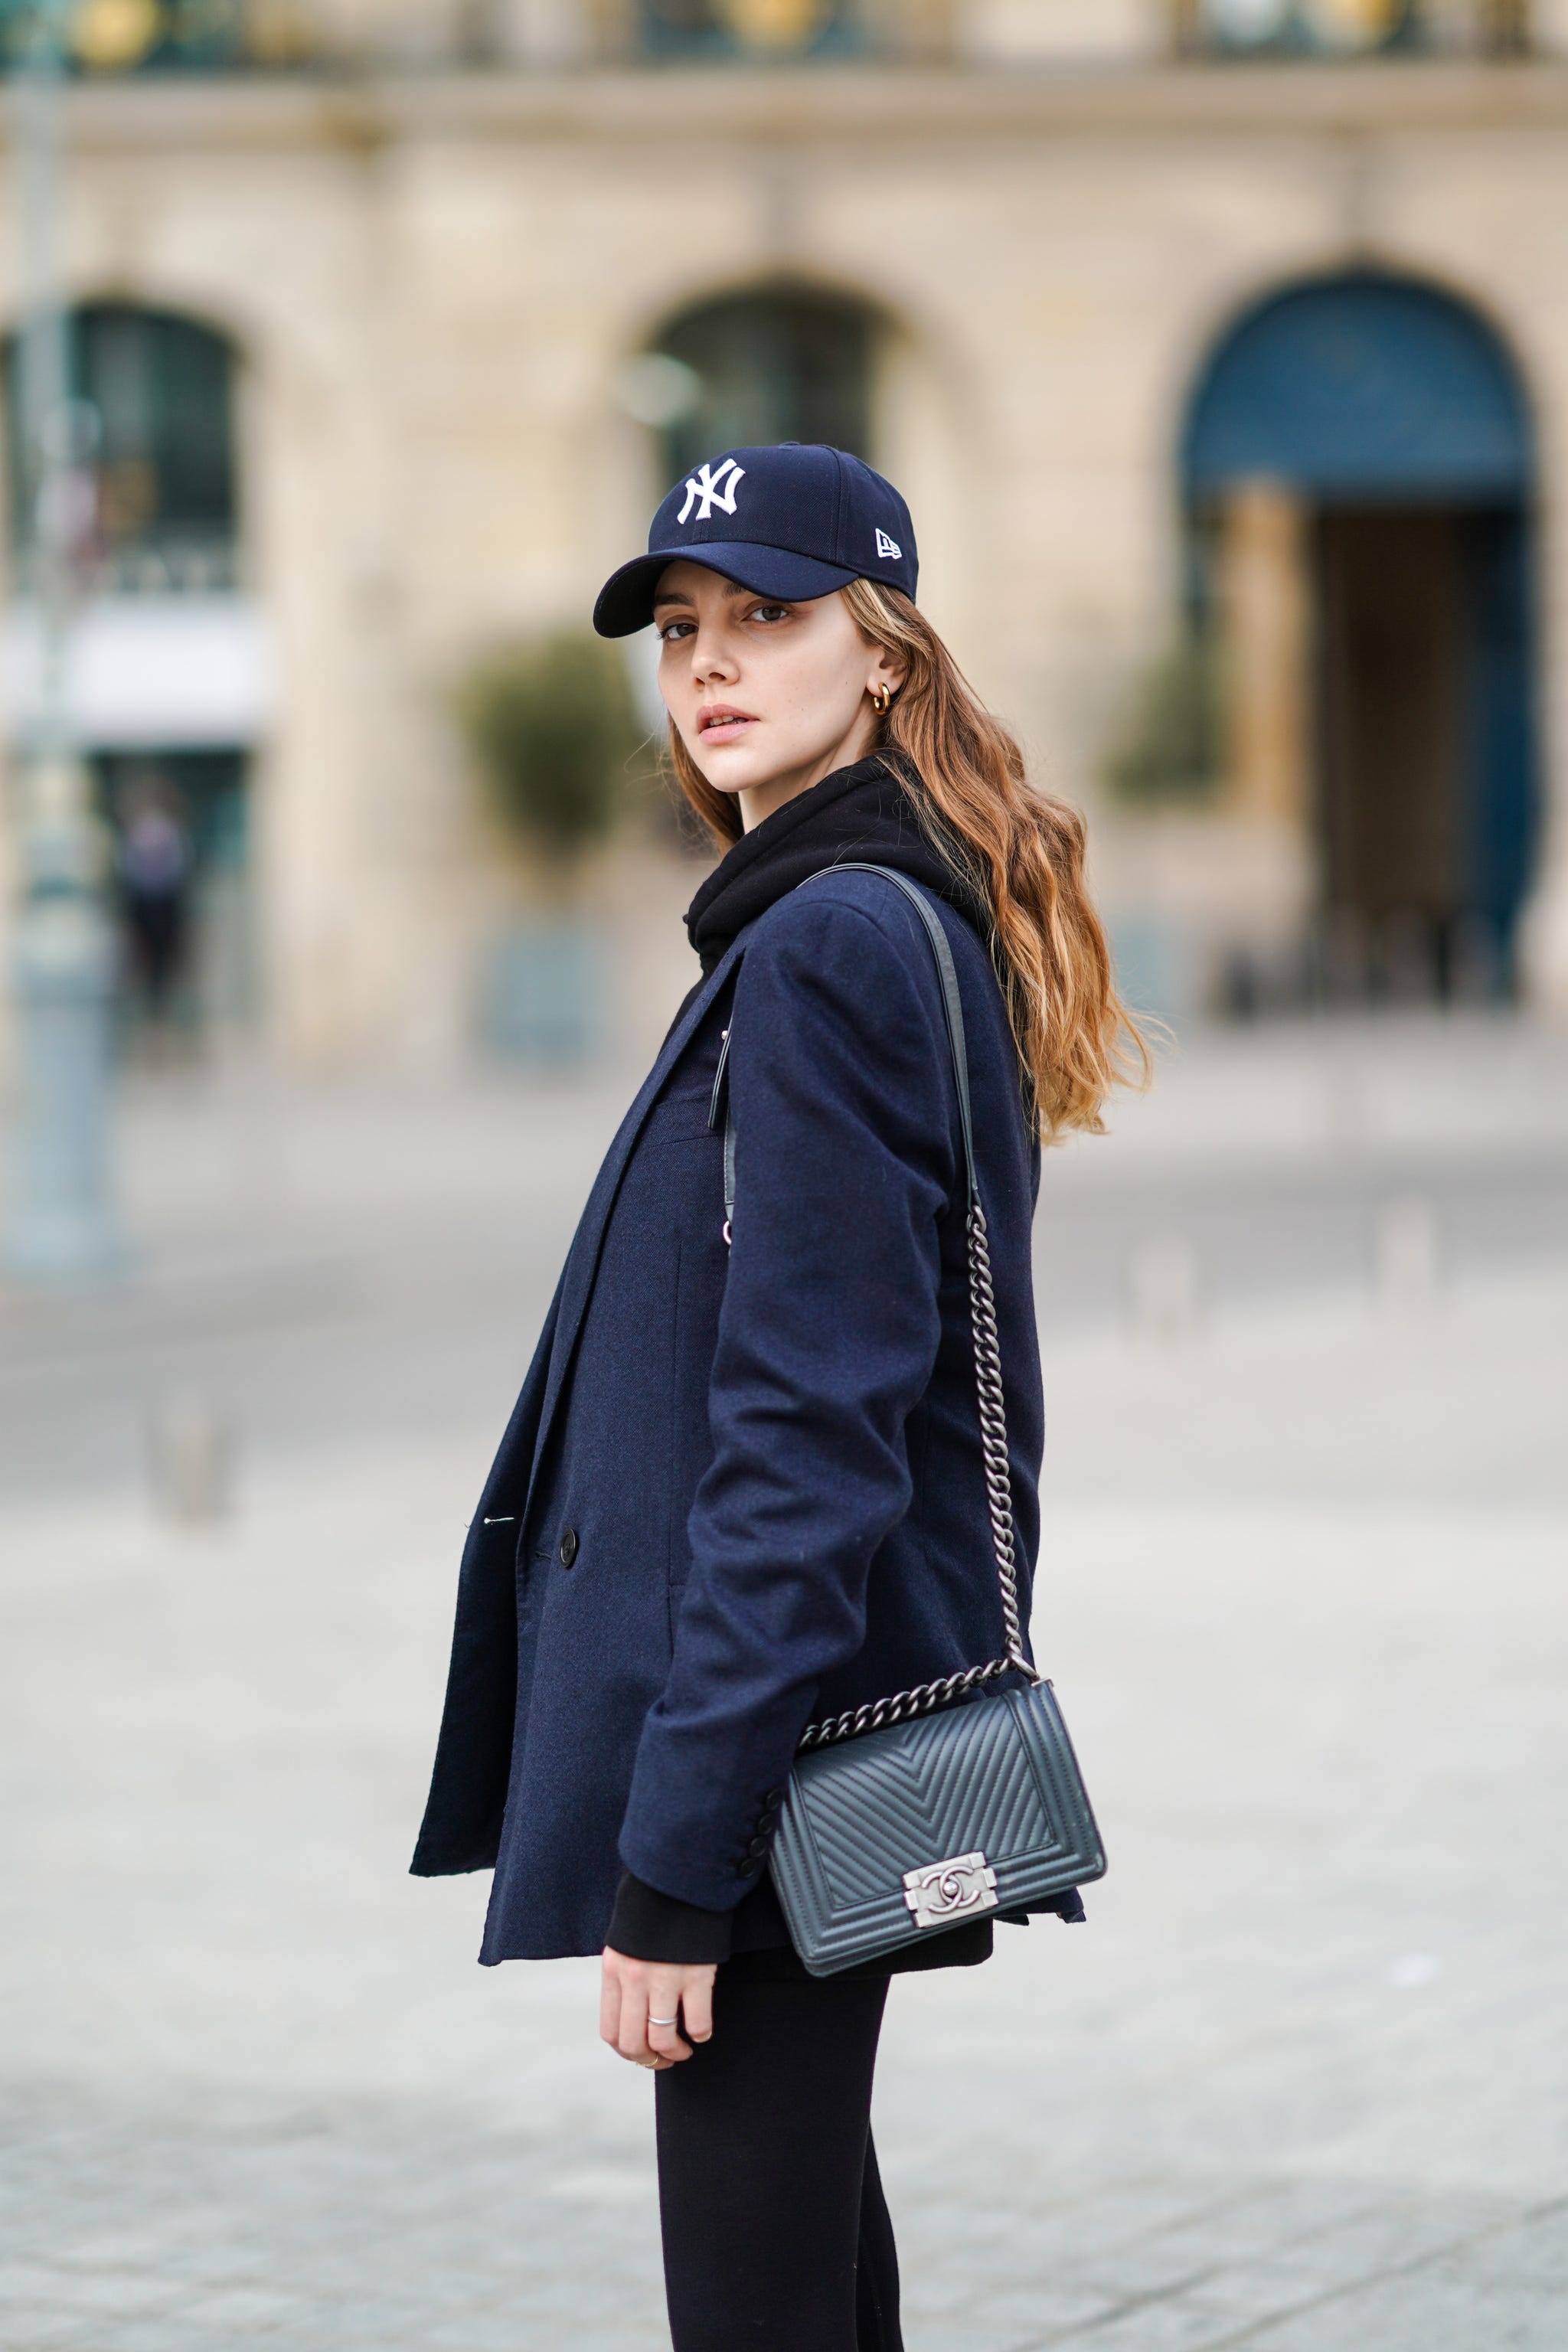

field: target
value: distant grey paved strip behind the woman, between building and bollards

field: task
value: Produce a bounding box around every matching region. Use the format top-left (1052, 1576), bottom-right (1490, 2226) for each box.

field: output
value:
top-left (0, 1016), bottom-right (1568, 1498)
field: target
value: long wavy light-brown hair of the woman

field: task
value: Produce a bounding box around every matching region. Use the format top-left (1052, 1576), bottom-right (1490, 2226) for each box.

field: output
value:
top-left (670, 581), bottom-right (1152, 1143)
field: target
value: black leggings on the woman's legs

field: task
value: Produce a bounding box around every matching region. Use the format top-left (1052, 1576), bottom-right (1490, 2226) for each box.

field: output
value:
top-left (654, 1968), bottom-right (903, 2352)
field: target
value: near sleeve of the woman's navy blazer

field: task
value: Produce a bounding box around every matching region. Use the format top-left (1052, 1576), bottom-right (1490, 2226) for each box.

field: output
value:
top-left (621, 877), bottom-right (957, 1909)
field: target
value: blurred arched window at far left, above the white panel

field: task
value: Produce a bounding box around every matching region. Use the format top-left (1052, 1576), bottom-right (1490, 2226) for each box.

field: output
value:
top-left (5, 303), bottom-right (237, 593)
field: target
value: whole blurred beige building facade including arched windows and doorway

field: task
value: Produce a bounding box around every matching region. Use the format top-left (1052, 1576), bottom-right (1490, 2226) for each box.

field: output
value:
top-left (0, 0), bottom-right (1568, 1060)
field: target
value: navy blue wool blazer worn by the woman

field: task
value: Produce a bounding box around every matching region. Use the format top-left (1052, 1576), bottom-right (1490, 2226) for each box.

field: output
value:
top-left (413, 871), bottom-right (1041, 1962)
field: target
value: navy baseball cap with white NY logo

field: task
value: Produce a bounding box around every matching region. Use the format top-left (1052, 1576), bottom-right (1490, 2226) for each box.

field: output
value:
top-left (593, 443), bottom-right (920, 638)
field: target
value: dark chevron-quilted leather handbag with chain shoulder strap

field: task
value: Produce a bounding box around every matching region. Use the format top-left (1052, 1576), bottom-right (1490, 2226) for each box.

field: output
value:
top-left (714, 861), bottom-right (1105, 1975)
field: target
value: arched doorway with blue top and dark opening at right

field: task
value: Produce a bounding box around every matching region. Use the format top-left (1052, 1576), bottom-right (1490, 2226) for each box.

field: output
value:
top-left (1182, 273), bottom-right (1535, 992)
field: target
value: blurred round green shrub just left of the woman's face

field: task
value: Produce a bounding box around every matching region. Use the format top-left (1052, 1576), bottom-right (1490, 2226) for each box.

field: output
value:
top-left (456, 628), bottom-right (644, 863)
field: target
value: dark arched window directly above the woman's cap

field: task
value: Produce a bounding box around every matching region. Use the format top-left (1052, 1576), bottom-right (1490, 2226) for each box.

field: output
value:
top-left (628, 287), bottom-right (877, 482)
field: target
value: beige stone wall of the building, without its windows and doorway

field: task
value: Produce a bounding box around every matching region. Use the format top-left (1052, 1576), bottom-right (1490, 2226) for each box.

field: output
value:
top-left (0, 64), bottom-right (1568, 1058)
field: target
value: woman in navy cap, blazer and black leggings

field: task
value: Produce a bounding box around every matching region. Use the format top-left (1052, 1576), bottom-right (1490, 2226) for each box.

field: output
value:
top-left (413, 443), bottom-right (1142, 2352)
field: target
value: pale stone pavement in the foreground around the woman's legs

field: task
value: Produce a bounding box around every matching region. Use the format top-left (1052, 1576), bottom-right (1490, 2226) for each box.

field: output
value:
top-left (0, 1025), bottom-right (1568, 2352)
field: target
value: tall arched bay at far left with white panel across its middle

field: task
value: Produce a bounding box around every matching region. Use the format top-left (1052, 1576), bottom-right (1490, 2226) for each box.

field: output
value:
top-left (5, 301), bottom-right (266, 1031)
